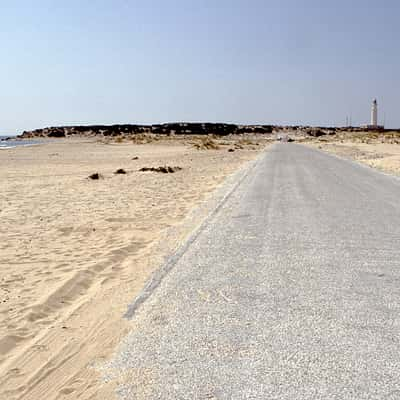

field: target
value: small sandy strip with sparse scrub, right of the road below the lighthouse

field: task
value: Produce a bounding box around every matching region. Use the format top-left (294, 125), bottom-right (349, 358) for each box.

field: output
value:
top-left (307, 140), bottom-right (400, 175)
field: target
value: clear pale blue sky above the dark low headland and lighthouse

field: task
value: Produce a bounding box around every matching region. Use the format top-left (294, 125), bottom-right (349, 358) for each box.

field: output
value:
top-left (0, 0), bottom-right (400, 134)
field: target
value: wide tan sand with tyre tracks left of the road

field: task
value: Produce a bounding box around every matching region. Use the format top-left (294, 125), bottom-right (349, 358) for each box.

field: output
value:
top-left (0, 139), bottom-right (263, 400)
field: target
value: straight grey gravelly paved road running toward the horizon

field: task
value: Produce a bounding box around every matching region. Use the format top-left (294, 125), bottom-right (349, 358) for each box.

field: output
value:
top-left (106, 144), bottom-right (400, 400)
